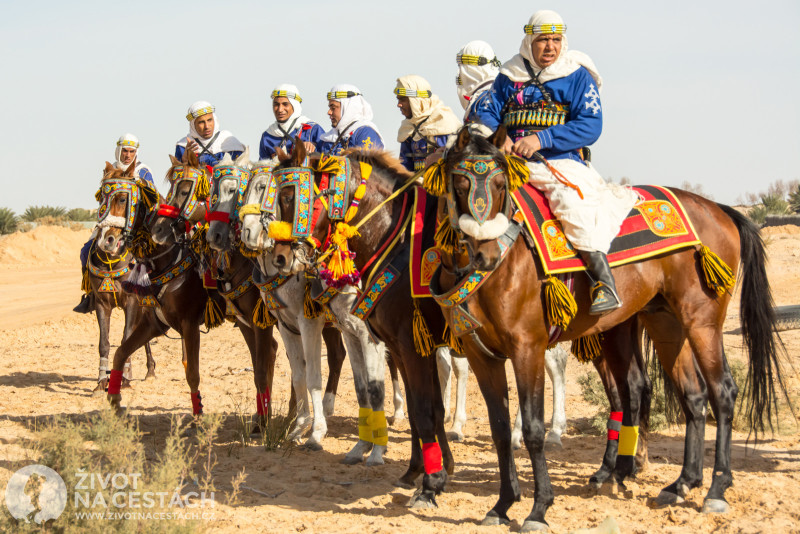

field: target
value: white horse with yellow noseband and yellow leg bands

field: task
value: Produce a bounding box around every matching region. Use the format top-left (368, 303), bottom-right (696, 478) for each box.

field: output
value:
top-left (240, 162), bottom-right (403, 466)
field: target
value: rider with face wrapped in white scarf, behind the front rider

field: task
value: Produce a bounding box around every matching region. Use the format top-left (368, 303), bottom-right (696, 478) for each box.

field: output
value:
top-left (456, 41), bottom-right (500, 123)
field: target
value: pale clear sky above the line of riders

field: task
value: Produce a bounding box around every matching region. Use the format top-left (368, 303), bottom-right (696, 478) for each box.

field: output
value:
top-left (0, 0), bottom-right (800, 214)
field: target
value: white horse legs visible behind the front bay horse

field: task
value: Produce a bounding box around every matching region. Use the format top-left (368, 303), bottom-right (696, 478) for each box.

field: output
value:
top-left (436, 343), bottom-right (569, 449)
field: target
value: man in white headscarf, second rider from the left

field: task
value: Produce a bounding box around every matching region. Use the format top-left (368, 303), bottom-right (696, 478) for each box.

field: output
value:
top-left (175, 100), bottom-right (244, 166)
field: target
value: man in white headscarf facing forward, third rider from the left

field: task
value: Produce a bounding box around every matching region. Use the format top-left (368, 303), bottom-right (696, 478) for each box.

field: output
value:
top-left (258, 83), bottom-right (325, 160)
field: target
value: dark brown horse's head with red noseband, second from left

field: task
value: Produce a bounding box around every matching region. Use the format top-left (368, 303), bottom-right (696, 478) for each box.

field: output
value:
top-left (152, 150), bottom-right (210, 245)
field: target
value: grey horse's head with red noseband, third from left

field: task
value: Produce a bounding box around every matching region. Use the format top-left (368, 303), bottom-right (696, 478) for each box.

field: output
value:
top-left (206, 149), bottom-right (250, 252)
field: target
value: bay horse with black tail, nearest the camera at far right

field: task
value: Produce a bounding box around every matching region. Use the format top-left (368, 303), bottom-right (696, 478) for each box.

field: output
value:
top-left (426, 127), bottom-right (782, 531)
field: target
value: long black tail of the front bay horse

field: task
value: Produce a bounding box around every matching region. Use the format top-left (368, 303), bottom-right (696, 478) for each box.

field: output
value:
top-left (718, 204), bottom-right (791, 436)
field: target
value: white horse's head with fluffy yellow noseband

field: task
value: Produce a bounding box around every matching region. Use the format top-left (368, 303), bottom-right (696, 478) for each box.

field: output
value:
top-left (239, 162), bottom-right (278, 252)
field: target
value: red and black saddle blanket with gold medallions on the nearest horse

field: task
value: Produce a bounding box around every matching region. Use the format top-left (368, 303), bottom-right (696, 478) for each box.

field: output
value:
top-left (513, 184), bottom-right (700, 274)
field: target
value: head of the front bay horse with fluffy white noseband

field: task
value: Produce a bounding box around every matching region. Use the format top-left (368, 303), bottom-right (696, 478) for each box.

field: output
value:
top-left (439, 126), bottom-right (524, 271)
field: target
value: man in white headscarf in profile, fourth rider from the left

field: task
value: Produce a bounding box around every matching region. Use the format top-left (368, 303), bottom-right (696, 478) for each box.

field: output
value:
top-left (317, 84), bottom-right (383, 156)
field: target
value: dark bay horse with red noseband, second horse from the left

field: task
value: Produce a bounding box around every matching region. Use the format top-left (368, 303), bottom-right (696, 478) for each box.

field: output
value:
top-left (103, 151), bottom-right (225, 418)
